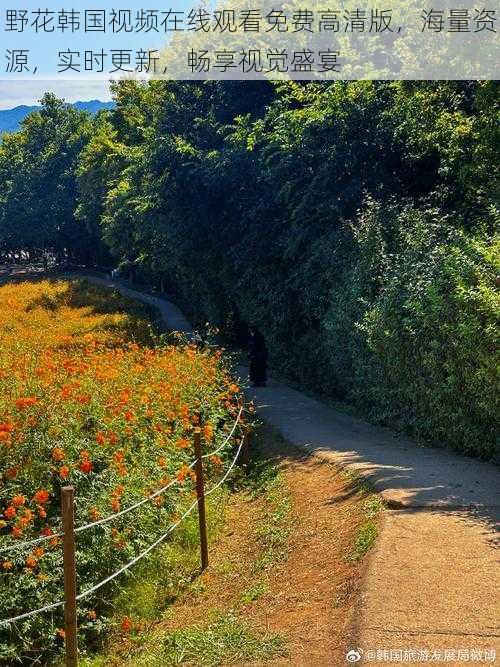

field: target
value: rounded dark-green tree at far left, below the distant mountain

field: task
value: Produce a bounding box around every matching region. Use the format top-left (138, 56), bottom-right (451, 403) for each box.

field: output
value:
top-left (0, 94), bottom-right (98, 264)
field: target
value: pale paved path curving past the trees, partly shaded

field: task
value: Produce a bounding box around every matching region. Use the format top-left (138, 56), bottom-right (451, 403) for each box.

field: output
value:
top-left (11, 278), bottom-right (500, 667)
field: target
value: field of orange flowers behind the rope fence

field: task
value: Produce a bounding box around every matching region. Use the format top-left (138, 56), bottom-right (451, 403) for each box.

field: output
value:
top-left (0, 280), bottom-right (246, 663)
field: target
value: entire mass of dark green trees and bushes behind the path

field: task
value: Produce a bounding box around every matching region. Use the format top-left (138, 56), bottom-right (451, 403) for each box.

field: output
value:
top-left (0, 81), bottom-right (499, 456)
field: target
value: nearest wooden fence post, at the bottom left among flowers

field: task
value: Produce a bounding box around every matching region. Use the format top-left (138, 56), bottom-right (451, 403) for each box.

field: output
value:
top-left (61, 486), bottom-right (78, 667)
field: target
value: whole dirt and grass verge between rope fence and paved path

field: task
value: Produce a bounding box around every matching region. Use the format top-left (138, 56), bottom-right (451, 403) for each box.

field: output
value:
top-left (87, 426), bottom-right (380, 667)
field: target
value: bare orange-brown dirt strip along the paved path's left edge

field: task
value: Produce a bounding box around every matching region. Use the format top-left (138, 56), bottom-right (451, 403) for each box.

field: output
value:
top-left (242, 436), bottom-right (376, 667)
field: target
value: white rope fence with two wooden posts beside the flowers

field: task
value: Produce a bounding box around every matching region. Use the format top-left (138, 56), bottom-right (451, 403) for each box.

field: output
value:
top-left (0, 406), bottom-right (248, 667)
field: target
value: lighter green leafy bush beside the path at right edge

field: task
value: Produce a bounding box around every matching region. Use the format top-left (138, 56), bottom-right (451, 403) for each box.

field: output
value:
top-left (325, 204), bottom-right (500, 458)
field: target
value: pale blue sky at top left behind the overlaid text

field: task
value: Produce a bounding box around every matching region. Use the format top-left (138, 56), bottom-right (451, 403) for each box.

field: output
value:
top-left (0, 0), bottom-right (188, 109)
